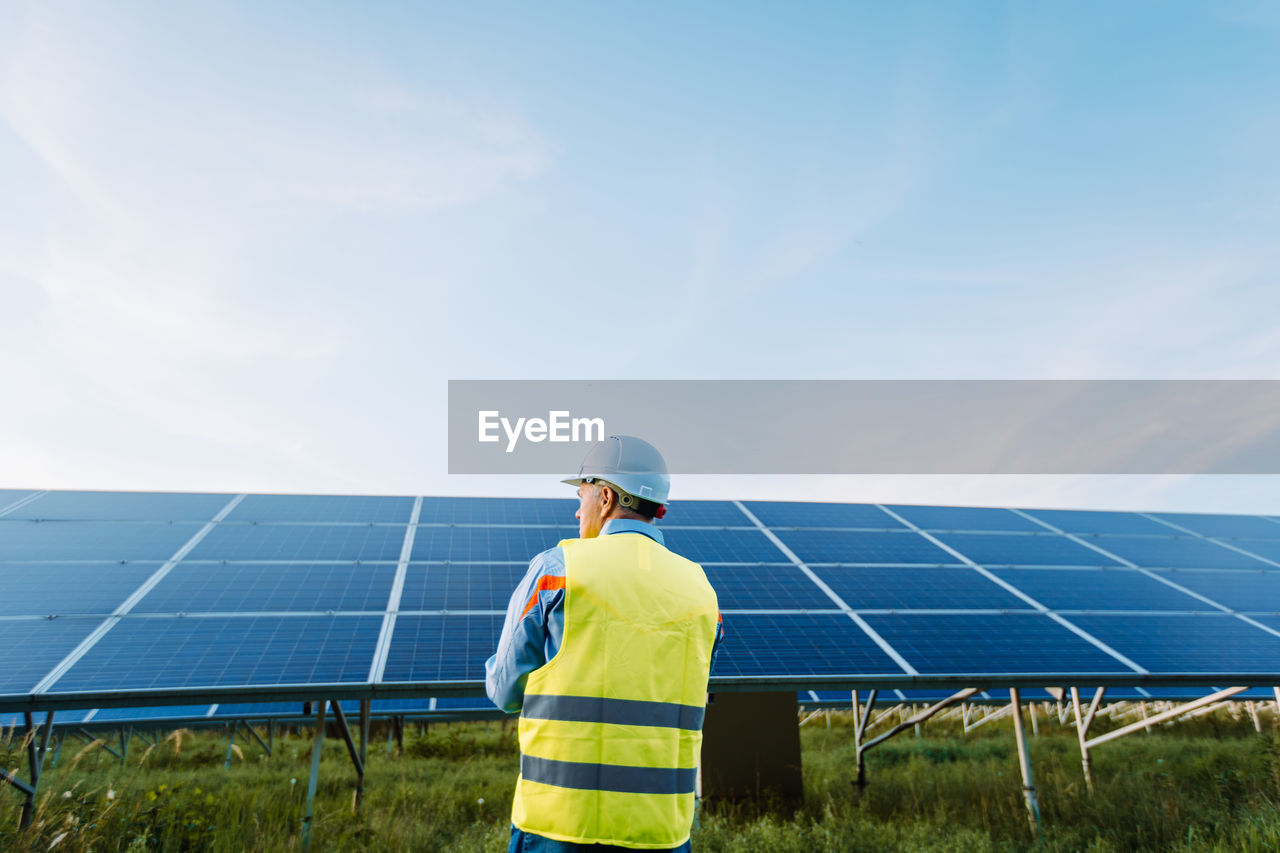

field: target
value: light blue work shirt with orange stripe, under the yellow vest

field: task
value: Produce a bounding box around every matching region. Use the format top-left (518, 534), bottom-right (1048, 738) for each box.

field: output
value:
top-left (484, 519), bottom-right (724, 713)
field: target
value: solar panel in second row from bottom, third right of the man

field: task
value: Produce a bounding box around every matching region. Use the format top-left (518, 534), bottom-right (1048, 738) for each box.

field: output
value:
top-left (977, 569), bottom-right (1215, 611)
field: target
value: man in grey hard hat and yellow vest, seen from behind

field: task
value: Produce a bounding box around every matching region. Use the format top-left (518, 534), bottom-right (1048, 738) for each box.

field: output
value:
top-left (485, 435), bottom-right (723, 853)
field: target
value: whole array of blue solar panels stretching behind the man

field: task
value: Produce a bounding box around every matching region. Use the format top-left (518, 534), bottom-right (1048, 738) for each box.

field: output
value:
top-left (0, 491), bottom-right (1280, 720)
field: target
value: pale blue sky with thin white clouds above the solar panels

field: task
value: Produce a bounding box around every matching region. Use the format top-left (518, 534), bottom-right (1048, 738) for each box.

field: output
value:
top-left (0, 0), bottom-right (1280, 514)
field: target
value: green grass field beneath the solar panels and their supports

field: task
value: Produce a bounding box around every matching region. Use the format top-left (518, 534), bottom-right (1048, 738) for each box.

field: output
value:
top-left (0, 712), bottom-right (1280, 853)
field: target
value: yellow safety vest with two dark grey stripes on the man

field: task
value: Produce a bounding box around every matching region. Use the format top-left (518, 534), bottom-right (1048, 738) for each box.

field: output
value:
top-left (511, 533), bottom-right (719, 849)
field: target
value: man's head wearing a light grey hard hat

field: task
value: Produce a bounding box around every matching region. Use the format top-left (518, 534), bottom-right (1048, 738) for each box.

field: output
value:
top-left (563, 435), bottom-right (671, 539)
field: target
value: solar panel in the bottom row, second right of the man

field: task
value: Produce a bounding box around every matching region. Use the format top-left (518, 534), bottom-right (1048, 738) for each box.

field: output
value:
top-left (863, 613), bottom-right (1133, 675)
